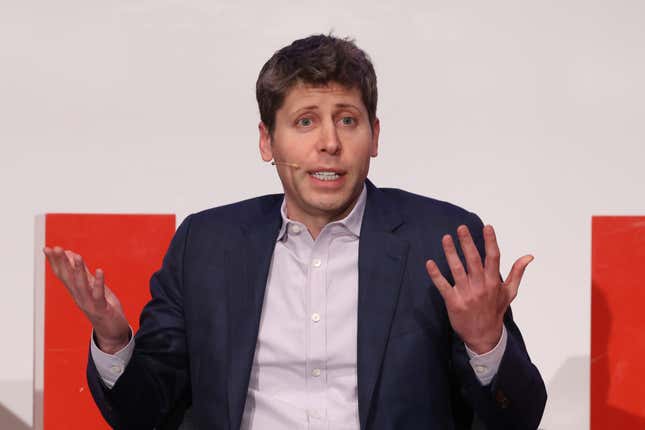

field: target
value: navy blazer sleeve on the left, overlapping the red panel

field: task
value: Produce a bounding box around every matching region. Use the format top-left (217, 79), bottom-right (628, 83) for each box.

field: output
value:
top-left (87, 217), bottom-right (191, 429)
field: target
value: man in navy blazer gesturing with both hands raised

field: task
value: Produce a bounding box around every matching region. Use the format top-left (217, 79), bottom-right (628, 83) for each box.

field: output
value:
top-left (45, 36), bottom-right (546, 430)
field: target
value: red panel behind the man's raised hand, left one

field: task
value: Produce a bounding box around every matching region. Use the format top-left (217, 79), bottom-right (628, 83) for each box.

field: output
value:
top-left (43, 214), bottom-right (175, 430)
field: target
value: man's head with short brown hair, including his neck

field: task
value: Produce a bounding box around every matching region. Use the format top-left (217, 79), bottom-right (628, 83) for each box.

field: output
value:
top-left (257, 36), bottom-right (380, 236)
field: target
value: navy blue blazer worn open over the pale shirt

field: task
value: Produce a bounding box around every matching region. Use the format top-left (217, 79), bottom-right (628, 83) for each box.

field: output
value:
top-left (87, 181), bottom-right (546, 430)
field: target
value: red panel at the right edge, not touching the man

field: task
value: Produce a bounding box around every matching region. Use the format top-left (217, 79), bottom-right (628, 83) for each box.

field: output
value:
top-left (591, 217), bottom-right (645, 430)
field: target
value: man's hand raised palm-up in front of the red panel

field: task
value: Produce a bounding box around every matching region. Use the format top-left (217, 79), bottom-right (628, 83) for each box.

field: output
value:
top-left (43, 247), bottom-right (130, 354)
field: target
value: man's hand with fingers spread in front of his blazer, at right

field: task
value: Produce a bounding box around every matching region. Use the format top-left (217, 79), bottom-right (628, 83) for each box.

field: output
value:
top-left (426, 225), bottom-right (533, 354)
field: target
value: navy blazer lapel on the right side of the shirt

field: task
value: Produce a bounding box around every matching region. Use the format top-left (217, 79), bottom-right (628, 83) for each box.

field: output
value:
top-left (357, 181), bottom-right (409, 429)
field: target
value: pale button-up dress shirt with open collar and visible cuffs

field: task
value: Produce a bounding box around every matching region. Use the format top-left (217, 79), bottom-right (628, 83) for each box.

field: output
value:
top-left (91, 187), bottom-right (507, 430)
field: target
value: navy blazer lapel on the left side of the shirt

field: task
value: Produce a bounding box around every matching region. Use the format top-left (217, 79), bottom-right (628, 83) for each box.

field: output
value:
top-left (228, 199), bottom-right (282, 429)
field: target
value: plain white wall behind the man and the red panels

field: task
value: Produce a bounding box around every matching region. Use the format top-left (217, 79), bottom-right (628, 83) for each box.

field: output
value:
top-left (0, 0), bottom-right (645, 430)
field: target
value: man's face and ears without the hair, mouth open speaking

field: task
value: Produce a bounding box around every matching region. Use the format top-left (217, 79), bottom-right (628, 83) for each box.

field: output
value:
top-left (259, 82), bottom-right (379, 222)
